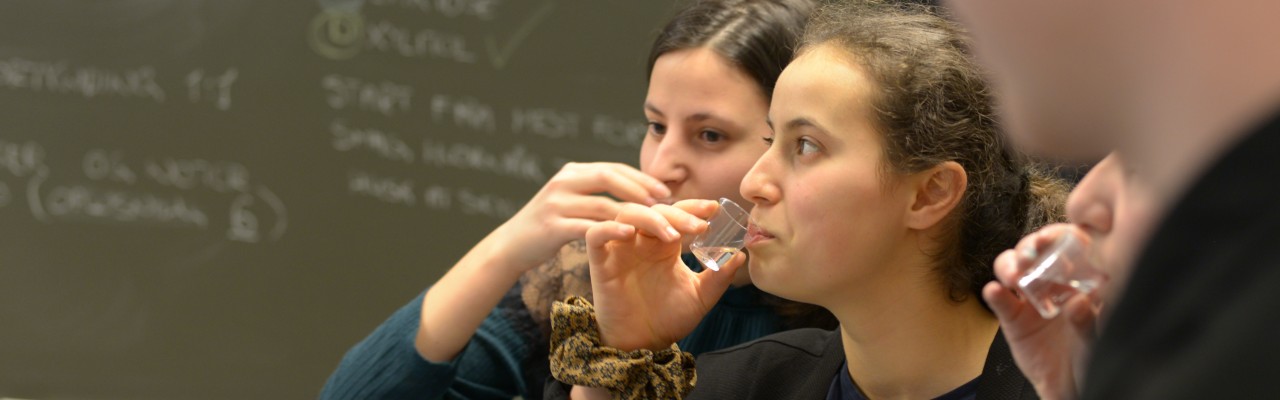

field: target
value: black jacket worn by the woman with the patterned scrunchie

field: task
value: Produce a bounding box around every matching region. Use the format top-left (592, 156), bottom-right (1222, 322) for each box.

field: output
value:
top-left (545, 328), bottom-right (1038, 400)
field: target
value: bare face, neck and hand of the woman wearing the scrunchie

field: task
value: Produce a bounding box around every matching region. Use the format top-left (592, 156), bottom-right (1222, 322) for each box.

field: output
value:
top-left (575, 45), bottom-right (997, 399)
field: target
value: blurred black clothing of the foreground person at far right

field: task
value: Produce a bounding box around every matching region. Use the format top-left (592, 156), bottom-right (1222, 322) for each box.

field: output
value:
top-left (1083, 110), bottom-right (1280, 399)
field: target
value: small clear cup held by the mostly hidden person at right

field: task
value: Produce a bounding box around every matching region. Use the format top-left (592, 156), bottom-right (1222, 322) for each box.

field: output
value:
top-left (1018, 229), bottom-right (1107, 319)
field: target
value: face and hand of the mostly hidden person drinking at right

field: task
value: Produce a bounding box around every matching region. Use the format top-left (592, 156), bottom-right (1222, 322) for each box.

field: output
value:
top-left (983, 155), bottom-right (1152, 399)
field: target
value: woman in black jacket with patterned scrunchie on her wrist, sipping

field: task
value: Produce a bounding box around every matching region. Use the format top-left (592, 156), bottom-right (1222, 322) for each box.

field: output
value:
top-left (547, 1), bottom-right (1066, 399)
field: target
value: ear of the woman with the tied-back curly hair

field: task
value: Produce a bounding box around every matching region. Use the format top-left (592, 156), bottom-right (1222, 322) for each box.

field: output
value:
top-left (906, 162), bottom-right (969, 229)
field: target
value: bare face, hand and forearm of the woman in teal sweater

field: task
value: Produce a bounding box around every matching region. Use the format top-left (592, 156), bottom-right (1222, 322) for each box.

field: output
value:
top-left (415, 47), bottom-right (768, 362)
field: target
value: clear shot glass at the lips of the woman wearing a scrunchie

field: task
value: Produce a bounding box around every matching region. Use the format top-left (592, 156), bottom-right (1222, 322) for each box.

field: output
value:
top-left (689, 197), bottom-right (751, 271)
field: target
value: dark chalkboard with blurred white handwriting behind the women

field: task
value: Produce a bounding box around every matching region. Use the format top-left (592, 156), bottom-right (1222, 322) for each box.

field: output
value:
top-left (0, 0), bottom-right (675, 399)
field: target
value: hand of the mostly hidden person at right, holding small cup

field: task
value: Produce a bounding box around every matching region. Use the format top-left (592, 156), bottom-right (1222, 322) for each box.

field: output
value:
top-left (982, 223), bottom-right (1101, 399)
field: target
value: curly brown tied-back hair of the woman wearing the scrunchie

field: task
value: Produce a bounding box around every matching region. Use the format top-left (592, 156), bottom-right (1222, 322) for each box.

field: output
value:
top-left (801, 0), bottom-right (1068, 301)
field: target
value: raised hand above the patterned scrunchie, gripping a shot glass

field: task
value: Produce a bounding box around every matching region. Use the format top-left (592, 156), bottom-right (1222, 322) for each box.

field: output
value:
top-left (586, 200), bottom-right (745, 350)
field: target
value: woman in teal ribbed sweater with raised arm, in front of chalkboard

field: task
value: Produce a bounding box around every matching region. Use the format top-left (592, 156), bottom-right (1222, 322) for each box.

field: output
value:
top-left (314, 0), bottom-right (833, 399)
